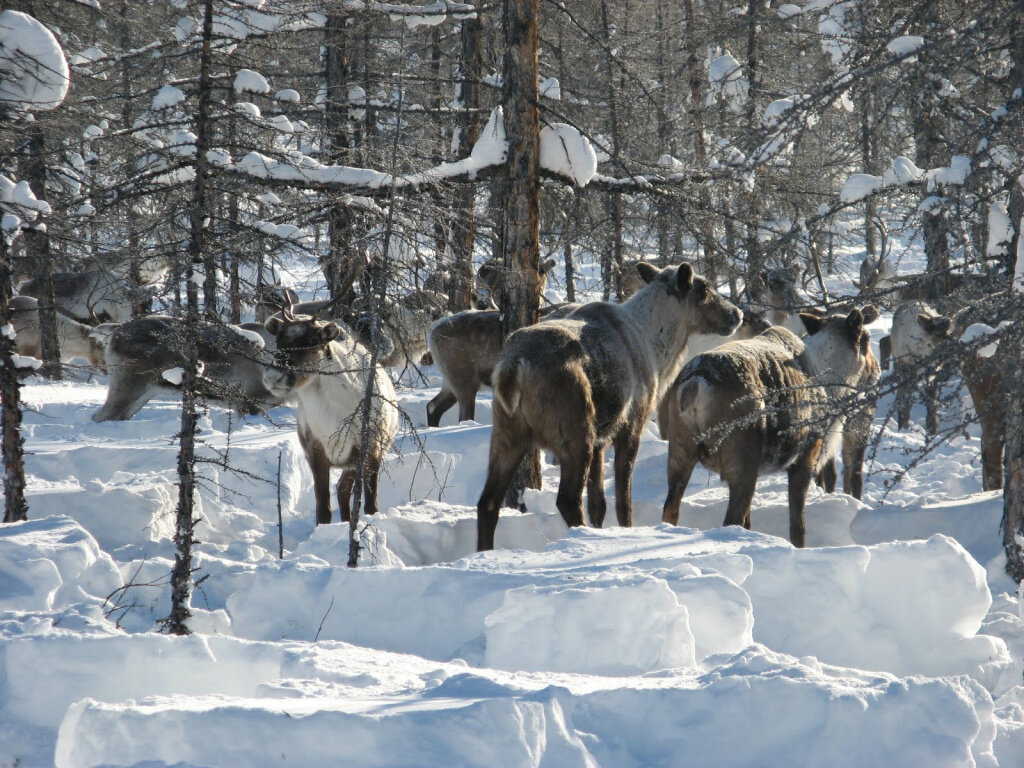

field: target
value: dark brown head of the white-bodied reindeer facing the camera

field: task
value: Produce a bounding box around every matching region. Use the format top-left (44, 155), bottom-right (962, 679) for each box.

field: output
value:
top-left (263, 307), bottom-right (343, 397)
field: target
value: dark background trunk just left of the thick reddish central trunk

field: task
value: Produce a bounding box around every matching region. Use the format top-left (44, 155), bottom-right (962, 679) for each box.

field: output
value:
top-left (447, 6), bottom-right (482, 312)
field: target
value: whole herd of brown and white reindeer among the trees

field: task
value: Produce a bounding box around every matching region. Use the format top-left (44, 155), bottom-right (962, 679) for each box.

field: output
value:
top-left (11, 252), bottom-right (1005, 550)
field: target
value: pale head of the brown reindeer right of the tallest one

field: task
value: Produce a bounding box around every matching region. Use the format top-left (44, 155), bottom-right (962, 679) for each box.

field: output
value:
top-left (800, 305), bottom-right (878, 387)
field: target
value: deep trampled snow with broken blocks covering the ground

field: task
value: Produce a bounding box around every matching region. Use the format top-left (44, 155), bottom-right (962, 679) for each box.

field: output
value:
top-left (0, 253), bottom-right (1024, 768)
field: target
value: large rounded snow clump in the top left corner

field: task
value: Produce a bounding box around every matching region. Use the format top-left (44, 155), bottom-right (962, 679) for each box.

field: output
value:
top-left (0, 10), bottom-right (71, 111)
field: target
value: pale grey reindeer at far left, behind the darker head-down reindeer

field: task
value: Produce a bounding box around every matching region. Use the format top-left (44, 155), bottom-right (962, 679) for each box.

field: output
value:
top-left (17, 269), bottom-right (153, 326)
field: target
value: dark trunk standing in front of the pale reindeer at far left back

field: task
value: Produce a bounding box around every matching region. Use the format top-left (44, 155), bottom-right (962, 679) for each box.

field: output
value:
top-left (25, 123), bottom-right (63, 379)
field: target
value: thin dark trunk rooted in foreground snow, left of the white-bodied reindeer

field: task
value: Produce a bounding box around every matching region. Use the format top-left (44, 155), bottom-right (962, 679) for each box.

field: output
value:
top-left (163, 0), bottom-right (213, 635)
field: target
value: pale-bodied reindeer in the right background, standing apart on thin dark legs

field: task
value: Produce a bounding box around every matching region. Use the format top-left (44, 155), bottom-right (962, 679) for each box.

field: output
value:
top-left (889, 301), bottom-right (951, 435)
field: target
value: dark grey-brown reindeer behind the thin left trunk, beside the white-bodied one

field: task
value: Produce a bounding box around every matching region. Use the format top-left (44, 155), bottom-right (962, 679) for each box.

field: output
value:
top-left (92, 314), bottom-right (281, 422)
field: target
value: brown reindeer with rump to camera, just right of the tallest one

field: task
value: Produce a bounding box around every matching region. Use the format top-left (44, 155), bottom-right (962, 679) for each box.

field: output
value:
top-left (662, 309), bottom-right (867, 547)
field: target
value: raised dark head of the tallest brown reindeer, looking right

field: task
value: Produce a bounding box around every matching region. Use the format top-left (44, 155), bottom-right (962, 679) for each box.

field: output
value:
top-left (630, 261), bottom-right (743, 336)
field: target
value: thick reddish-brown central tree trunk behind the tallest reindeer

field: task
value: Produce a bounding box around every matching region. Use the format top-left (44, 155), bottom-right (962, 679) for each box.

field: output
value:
top-left (502, 0), bottom-right (542, 507)
